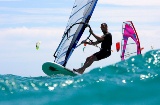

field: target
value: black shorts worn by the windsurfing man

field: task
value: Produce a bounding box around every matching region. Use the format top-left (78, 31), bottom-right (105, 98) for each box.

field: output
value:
top-left (93, 50), bottom-right (111, 60)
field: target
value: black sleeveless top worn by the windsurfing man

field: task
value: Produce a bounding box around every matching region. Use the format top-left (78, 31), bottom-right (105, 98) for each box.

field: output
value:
top-left (101, 32), bottom-right (112, 50)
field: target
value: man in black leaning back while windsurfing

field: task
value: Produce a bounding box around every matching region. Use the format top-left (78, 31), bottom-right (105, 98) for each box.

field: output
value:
top-left (73, 23), bottom-right (112, 74)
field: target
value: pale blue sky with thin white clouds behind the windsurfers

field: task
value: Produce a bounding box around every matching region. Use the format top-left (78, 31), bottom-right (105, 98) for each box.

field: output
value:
top-left (0, 0), bottom-right (160, 76)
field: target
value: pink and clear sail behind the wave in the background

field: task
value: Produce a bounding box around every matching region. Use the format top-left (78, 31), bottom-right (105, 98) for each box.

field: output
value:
top-left (121, 21), bottom-right (141, 60)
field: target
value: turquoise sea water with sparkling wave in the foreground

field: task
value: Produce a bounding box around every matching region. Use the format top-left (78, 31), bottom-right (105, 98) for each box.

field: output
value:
top-left (0, 50), bottom-right (160, 105)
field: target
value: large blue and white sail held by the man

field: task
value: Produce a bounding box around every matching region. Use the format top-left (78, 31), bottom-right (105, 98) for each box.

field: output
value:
top-left (54, 0), bottom-right (98, 66)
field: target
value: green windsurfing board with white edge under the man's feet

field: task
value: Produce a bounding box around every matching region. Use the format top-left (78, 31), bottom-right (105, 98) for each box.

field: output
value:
top-left (42, 62), bottom-right (80, 76)
